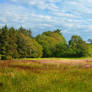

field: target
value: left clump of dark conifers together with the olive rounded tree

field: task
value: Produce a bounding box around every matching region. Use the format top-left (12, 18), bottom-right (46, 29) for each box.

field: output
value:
top-left (0, 26), bottom-right (42, 59)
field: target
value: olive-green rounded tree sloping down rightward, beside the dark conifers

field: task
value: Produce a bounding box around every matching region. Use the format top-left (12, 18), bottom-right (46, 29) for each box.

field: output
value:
top-left (17, 32), bottom-right (42, 58)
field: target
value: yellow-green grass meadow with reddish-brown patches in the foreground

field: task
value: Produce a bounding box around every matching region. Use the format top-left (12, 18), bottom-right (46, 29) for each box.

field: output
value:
top-left (0, 59), bottom-right (92, 92)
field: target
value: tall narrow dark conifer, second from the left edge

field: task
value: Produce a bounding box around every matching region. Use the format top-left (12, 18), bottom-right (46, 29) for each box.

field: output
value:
top-left (7, 27), bottom-right (18, 58)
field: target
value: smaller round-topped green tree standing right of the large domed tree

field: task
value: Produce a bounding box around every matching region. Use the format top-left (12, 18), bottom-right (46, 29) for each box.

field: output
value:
top-left (69, 35), bottom-right (87, 57)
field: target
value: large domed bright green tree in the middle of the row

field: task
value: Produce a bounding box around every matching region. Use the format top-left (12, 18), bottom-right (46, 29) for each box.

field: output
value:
top-left (36, 31), bottom-right (66, 57)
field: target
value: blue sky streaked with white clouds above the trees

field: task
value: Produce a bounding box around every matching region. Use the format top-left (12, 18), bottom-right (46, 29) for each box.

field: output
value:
top-left (0, 0), bottom-right (92, 41)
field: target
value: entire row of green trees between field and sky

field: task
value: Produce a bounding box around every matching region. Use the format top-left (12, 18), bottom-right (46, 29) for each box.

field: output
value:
top-left (0, 26), bottom-right (92, 60)
